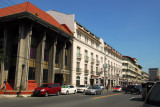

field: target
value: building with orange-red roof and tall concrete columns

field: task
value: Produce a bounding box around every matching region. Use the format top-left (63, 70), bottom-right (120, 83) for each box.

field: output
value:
top-left (0, 2), bottom-right (73, 90)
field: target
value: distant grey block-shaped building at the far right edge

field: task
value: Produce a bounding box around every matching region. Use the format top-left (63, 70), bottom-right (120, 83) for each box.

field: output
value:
top-left (149, 68), bottom-right (160, 81)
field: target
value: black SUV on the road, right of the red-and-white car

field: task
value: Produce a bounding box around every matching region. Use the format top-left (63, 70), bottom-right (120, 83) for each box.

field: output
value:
top-left (125, 85), bottom-right (142, 94)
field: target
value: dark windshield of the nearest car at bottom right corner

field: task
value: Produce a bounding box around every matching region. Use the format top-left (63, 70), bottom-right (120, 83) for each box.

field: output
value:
top-left (146, 82), bottom-right (160, 106)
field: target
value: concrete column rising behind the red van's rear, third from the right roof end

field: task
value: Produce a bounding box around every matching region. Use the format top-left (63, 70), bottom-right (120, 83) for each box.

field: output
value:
top-left (48, 41), bottom-right (57, 82)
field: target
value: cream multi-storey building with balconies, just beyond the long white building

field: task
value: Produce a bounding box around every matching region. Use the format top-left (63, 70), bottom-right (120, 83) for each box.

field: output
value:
top-left (122, 56), bottom-right (142, 85)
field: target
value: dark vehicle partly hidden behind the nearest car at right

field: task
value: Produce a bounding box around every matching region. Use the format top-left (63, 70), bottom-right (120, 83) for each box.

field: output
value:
top-left (142, 81), bottom-right (156, 99)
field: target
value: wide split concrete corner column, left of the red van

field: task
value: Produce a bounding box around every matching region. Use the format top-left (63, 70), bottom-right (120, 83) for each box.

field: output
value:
top-left (14, 23), bottom-right (32, 90)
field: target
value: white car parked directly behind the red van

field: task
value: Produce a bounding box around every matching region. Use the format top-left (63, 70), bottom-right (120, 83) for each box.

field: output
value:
top-left (61, 85), bottom-right (77, 95)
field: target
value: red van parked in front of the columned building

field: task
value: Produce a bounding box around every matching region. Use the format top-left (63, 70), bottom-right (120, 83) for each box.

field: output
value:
top-left (33, 83), bottom-right (61, 97)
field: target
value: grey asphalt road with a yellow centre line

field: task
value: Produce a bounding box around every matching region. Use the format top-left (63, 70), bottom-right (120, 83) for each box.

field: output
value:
top-left (0, 91), bottom-right (143, 107)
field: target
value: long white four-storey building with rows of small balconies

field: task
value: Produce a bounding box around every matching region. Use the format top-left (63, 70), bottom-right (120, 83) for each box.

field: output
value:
top-left (47, 10), bottom-right (122, 86)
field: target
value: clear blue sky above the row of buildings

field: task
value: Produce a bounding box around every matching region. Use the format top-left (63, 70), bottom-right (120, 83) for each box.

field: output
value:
top-left (0, 0), bottom-right (160, 72)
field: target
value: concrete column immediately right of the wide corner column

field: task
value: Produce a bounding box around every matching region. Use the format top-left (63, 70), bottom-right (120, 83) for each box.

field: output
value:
top-left (35, 31), bottom-right (46, 86)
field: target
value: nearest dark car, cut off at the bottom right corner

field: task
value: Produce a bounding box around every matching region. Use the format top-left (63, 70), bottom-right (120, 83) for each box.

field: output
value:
top-left (143, 81), bottom-right (160, 107)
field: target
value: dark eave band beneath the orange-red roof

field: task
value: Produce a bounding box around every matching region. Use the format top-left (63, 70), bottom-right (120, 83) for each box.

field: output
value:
top-left (0, 11), bottom-right (73, 38)
